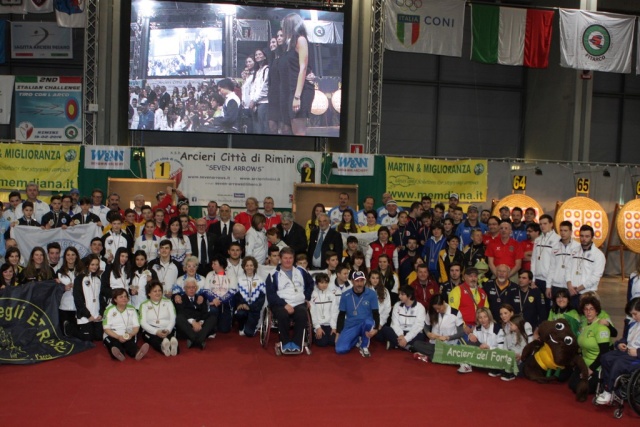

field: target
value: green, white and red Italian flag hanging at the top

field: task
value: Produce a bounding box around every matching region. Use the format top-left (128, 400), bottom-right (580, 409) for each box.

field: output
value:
top-left (471, 4), bottom-right (554, 68)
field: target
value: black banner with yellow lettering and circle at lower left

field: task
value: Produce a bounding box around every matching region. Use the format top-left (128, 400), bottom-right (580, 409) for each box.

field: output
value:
top-left (0, 281), bottom-right (93, 365)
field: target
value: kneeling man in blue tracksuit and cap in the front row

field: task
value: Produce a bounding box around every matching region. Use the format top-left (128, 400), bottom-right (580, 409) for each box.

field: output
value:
top-left (336, 271), bottom-right (380, 357)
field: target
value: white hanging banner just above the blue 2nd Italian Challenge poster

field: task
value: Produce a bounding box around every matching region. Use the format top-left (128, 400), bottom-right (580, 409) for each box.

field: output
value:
top-left (11, 21), bottom-right (73, 59)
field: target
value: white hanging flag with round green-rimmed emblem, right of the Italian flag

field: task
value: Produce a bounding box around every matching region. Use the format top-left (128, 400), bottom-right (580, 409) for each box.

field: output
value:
top-left (560, 9), bottom-right (636, 73)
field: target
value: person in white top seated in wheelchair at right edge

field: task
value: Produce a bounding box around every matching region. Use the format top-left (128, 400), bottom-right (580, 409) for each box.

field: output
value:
top-left (596, 297), bottom-right (640, 405)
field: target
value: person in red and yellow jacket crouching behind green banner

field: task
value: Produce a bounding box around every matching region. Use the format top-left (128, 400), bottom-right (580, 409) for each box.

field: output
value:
top-left (449, 267), bottom-right (489, 335)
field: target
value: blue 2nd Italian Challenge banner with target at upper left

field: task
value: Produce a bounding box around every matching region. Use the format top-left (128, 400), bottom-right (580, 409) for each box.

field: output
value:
top-left (15, 76), bottom-right (82, 142)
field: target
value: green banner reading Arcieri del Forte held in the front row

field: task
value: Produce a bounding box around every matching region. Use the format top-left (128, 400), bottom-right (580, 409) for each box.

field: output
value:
top-left (433, 341), bottom-right (518, 374)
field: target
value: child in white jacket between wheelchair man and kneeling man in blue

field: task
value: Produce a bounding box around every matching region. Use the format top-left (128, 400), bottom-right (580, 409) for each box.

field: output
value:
top-left (310, 273), bottom-right (337, 347)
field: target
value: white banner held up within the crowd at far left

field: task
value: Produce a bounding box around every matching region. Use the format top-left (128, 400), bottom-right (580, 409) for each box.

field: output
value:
top-left (11, 223), bottom-right (102, 258)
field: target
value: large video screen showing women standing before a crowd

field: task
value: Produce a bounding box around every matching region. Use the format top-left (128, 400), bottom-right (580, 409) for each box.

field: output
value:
top-left (127, 0), bottom-right (345, 137)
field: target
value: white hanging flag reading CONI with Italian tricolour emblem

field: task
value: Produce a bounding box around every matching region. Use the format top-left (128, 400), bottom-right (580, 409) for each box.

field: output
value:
top-left (384, 0), bottom-right (465, 56)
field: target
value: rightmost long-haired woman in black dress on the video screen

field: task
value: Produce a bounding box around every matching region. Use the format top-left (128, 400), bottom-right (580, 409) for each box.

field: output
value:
top-left (281, 13), bottom-right (315, 136)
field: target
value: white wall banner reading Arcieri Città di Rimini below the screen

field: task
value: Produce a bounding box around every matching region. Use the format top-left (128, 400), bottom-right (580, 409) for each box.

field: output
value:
top-left (145, 147), bottom-right (322, 208)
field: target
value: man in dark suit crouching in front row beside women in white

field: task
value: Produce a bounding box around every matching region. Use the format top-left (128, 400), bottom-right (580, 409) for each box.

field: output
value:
top-left (173, 277), bottom-right (218, 350)
